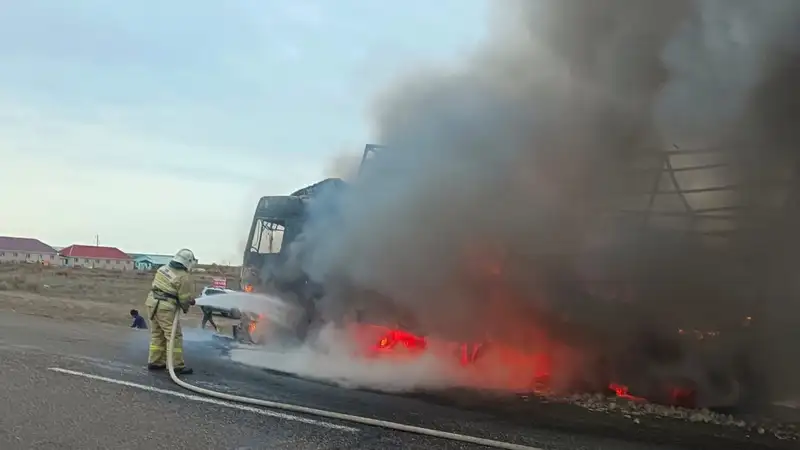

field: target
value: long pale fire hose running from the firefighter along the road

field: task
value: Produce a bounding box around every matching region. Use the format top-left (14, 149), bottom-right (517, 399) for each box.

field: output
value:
top-left (167, 308), bottom-right (543, 450)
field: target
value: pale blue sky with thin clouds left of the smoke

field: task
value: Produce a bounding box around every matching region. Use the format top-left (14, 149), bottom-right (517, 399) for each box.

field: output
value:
top-left (0, 0), bottom-right (487, 264)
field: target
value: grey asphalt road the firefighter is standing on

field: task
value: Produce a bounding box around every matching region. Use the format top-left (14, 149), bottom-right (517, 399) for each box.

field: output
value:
top-left (0, 313), bottom-right (792, 450)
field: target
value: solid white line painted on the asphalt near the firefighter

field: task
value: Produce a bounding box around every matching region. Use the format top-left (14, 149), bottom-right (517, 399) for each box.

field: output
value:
top-left (49, 367), bottom-right (361, 433)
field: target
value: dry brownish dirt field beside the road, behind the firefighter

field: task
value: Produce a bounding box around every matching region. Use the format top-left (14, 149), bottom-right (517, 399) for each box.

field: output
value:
top-left (0, 264), bottom-right (239, 326)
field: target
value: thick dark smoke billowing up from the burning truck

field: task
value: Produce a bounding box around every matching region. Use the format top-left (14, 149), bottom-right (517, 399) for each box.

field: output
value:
top-left (290, 0), bottom-right (800, 404)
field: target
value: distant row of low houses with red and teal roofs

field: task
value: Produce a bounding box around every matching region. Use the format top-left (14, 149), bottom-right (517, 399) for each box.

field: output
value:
top-left (0, 236), bottom-right (234, 271)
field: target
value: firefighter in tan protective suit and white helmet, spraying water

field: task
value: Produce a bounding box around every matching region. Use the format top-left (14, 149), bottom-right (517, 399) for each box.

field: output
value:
top-left (145, 248), bottom-right (197, 375)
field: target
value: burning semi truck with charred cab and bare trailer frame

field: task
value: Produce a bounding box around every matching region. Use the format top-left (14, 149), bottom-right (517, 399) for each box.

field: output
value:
top-left (236, 145), bottom-right (791, 408)
